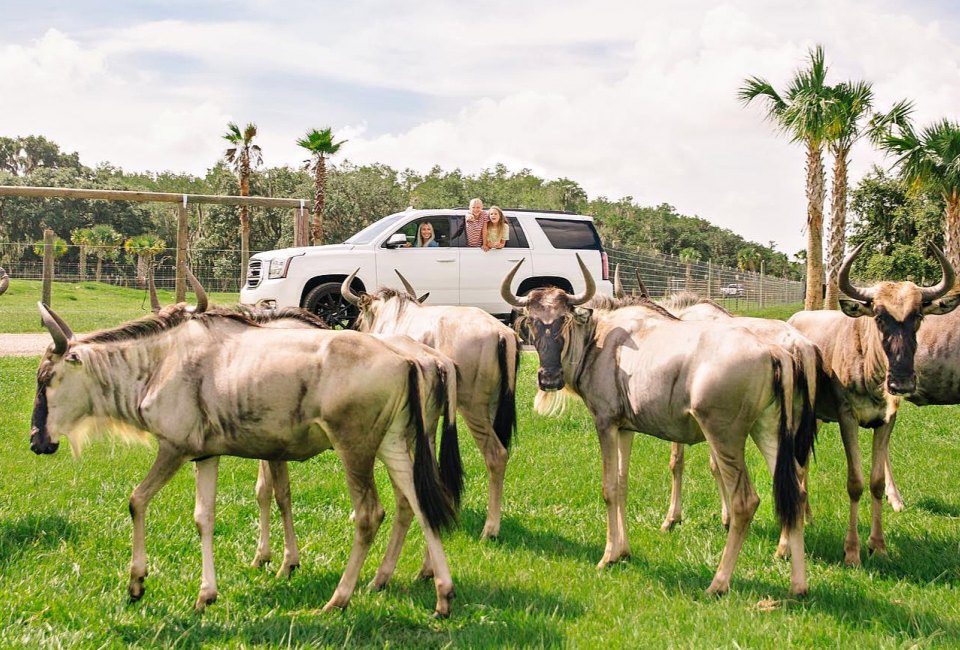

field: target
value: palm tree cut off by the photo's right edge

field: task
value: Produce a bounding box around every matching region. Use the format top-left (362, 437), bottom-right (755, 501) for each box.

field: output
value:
top-left (879, 119), bottom-right (960, 268)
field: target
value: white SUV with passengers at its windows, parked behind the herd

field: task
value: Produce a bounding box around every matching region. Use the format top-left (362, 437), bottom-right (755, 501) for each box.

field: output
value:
top-left (240, 208), bottom-right (613, 327)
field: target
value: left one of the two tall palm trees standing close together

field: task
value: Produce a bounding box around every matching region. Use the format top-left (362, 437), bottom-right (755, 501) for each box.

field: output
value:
top-left (737, 45), bottom-right (830, 309)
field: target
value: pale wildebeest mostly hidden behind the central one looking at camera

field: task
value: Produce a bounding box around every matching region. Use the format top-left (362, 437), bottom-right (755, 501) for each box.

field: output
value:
top-left (648, 293), bottom-right (829, 536)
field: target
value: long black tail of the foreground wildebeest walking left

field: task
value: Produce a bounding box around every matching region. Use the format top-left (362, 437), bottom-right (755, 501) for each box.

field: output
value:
top-left (407, 361), bottom-right (457, 530)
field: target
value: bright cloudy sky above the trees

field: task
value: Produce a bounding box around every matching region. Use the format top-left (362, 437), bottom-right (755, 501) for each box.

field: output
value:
top-left (0, 0), bottom-right (960, 255)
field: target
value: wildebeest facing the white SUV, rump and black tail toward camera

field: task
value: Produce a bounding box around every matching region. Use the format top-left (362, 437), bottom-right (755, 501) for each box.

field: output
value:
top-left (341, 272), bottom-right (520, 538)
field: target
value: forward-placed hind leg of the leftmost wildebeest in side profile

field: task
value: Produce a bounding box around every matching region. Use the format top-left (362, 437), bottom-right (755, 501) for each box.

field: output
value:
top-left (323, 450), bottom-right (384, 612)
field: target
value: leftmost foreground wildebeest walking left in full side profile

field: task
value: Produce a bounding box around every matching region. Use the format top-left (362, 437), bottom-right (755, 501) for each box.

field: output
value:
top-left (31, 305), bottom-right (456, 615)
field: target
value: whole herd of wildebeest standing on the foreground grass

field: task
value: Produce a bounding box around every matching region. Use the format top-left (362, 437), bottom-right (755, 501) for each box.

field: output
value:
top-left (20, 243), bottom-right (960, 616)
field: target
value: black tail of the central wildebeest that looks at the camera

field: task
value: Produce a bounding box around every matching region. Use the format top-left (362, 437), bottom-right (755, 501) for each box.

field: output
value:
top-left (772, 355), bottom-right (802, 530)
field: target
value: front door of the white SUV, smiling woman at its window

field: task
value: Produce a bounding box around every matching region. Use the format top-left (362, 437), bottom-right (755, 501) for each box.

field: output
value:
top-left (376, 215), bottom-right (460, 305)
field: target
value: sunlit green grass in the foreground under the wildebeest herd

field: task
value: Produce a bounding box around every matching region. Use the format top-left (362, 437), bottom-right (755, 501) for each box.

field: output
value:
top-left (0, 354), bottom-right (960, 648)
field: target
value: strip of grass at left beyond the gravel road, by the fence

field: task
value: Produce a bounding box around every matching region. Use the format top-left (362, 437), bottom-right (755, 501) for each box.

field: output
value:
top-left (0, 280), bottom-right (239, 334)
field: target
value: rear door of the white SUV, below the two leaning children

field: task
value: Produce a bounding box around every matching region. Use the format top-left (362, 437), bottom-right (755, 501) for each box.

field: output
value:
top-left (452, 216), bottom-right (533, 314)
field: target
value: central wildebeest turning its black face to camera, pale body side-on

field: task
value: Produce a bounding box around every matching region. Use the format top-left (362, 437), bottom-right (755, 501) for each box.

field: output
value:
top-left (501, 261), bottom-right (809, 594)
